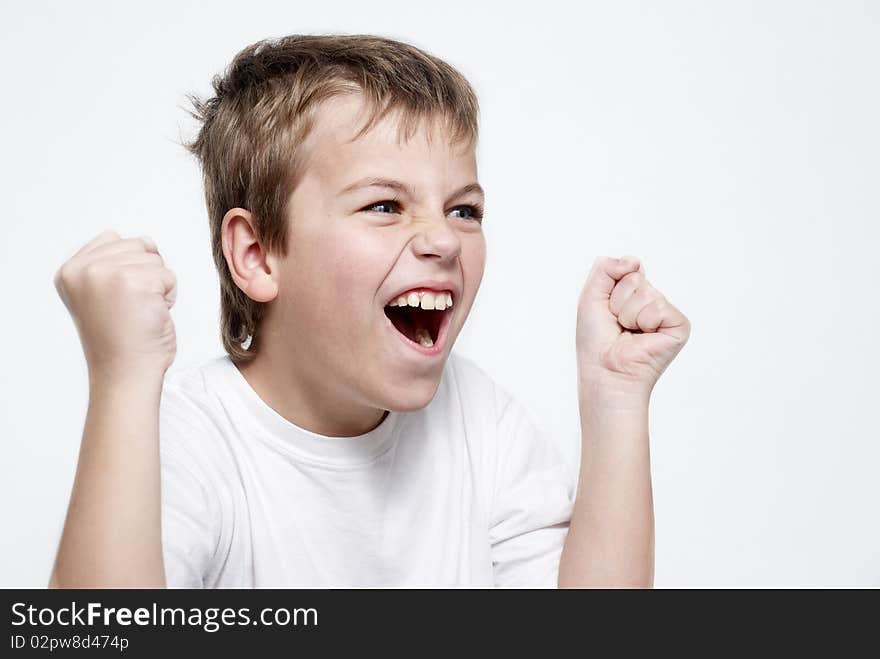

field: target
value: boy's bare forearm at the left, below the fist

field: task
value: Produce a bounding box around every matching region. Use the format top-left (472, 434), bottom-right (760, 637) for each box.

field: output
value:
top-left (50, 372), bottom-right (165, 588)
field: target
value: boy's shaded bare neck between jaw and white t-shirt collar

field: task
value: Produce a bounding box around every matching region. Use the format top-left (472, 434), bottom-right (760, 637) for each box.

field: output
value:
top-left (237, 326), bottom-right (388, 437)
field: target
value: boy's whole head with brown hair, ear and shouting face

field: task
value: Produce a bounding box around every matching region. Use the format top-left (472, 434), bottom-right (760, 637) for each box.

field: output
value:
top-left (188, 35), bottom-right (485, 410)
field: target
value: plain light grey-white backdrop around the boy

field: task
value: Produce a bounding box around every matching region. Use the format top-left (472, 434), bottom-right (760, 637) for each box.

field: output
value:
top-left (0, 0), bottom-right (880, 587)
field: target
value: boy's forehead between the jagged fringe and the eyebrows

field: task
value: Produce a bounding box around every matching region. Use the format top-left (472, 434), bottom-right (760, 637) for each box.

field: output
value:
top-left (303, 94), bottom-right (476, 189)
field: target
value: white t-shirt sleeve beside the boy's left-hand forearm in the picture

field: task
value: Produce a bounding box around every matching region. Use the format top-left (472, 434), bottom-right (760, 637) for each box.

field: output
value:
top-left (159, 384), bottom-right (220, 588)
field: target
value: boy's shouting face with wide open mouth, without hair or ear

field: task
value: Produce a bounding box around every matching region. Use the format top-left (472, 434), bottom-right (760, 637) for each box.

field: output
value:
top-left (272, 96), bottom-right (486, 411)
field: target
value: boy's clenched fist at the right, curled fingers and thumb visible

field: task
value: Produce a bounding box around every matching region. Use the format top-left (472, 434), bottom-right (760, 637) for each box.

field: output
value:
top-left (577, 256), bottom-right (691, 398)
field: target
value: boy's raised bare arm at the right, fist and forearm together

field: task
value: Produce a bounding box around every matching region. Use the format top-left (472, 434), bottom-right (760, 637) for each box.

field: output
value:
top-left (558, 257), bottom-right (690, 587)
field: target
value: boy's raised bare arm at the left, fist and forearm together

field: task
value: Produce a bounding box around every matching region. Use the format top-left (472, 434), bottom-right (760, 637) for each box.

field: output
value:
top-left (49, 231), bottom-right (177, 588)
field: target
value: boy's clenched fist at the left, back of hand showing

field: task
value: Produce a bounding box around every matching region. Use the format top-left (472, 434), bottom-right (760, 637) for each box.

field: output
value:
top-left (55, 231), bottom-right (177, 376)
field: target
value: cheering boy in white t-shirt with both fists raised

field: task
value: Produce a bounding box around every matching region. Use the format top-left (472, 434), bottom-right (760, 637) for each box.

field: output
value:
top-left (50, 35), bottom-right (689, 587)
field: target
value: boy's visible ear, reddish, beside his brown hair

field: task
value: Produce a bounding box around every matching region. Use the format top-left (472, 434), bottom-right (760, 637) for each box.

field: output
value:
top-left (220, 208), bottom-right (278, 302)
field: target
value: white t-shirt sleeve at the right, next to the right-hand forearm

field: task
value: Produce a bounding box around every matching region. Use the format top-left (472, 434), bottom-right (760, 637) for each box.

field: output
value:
top-left (489, 386), bottom-right (577, 588)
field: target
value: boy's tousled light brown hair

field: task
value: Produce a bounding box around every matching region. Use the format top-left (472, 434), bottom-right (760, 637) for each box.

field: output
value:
top-left (185, 34), bottom-right (479, 362)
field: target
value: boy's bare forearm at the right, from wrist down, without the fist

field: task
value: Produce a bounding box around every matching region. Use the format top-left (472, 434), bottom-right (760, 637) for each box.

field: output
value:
top-left (558, 388), bottom-right (654, 588)
